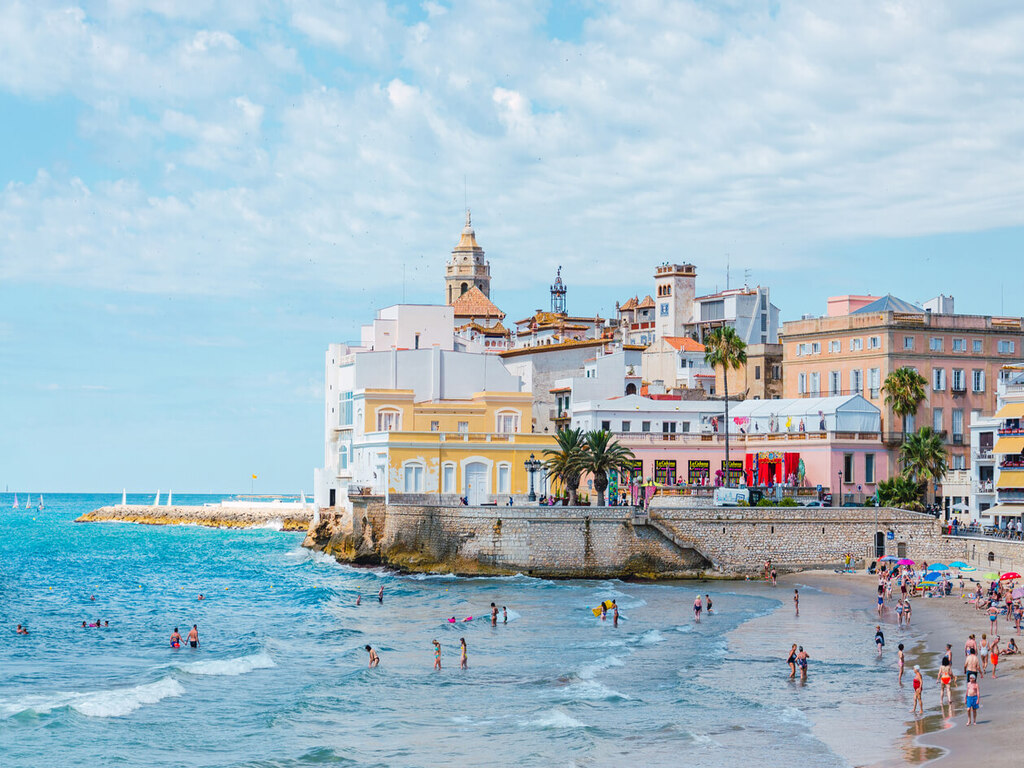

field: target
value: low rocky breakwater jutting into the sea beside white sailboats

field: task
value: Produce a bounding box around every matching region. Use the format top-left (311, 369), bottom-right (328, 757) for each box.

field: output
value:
top-left (75, 504), bottom-right (313, 530)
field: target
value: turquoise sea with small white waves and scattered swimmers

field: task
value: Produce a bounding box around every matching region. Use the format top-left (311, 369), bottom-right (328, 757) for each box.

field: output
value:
top-left (0, 494), bottom-right (929, 768)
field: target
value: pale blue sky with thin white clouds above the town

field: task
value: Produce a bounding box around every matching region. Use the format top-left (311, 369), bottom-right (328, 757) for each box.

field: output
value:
top-left (0, 0), bottom-right (1024, 493)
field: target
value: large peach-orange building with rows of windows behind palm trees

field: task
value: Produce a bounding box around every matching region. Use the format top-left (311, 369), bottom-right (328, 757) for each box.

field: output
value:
top-left (779, 296), bottom-right (1024, 487)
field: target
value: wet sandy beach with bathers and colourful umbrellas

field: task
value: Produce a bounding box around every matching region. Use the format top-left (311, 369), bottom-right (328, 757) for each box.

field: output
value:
top-left (779, 571), bottom-right (1024, 768)
